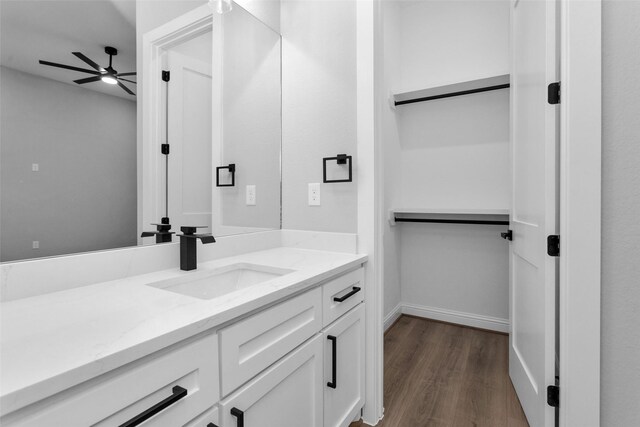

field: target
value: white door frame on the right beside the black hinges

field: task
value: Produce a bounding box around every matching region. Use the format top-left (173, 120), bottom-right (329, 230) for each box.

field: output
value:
top-left (559, 0), bottom-right (602, 427)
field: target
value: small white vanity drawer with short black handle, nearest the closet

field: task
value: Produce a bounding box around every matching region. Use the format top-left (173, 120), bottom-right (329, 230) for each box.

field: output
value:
top-left (322, 268), bottom-right (364, 327)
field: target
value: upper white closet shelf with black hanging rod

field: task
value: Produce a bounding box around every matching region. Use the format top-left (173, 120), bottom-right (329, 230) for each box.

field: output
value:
top-left (392, 74), bottom-right (511, 106)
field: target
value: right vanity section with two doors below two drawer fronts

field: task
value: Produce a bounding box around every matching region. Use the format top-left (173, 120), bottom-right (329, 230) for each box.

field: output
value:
top-left (219, 268), bottom-right (365, 427)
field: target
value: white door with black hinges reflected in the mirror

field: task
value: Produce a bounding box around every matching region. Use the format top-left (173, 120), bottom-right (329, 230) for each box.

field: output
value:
top-left (168, 51), bottom-right (212, 232)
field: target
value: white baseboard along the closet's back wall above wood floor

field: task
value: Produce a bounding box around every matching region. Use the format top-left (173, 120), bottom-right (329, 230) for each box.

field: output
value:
top-left (402, 304), bottom-right (510, 333)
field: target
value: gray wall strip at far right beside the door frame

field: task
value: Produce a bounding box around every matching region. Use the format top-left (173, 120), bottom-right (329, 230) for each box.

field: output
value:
top-left (601, 1), bottom-right (640, 427)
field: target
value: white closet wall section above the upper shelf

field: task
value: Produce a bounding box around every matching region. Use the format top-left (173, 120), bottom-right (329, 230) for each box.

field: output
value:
top-left (395, 0), bottom-right (509, 92)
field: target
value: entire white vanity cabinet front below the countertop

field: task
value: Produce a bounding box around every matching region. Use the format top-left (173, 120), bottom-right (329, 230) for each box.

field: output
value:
top-left (0, 268), bottom-right (365, 427)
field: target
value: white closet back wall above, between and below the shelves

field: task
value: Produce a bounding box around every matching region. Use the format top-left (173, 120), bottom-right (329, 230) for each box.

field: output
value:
top-left (383, 1), bottom-right (510, 330)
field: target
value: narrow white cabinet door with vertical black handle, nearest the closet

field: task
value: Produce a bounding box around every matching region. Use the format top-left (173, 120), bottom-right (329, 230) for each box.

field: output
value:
top-left (322, 304), bottom-right (364, 427)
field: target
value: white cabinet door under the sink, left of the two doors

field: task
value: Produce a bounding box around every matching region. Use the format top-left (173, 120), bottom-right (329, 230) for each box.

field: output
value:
top-left (220, 335), bottom-right (322, 427)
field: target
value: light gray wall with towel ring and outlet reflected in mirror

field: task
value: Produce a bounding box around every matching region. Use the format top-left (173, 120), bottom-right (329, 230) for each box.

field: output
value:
top-left (220, 8), bottom-right (282, 229)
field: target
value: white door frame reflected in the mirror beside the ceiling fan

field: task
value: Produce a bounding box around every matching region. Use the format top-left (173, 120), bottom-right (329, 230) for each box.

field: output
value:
top-left (138, 4), bottom-right (216, 244)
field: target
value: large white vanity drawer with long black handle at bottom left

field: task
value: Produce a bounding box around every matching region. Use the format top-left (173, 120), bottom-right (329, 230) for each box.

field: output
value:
top-left (3, 335), bottom-right (219, 427)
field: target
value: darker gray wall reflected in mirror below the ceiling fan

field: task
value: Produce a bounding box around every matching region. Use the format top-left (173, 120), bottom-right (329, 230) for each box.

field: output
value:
top-left (0, 67), bottom-right (137, 261)
